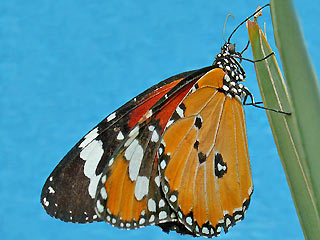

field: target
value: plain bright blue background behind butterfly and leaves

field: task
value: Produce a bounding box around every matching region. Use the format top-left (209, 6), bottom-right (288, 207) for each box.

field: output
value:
top-left (0, 0), bottom-right (320, 240)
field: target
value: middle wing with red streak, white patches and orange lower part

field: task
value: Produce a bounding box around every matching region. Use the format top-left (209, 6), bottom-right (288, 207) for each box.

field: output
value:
top-left (95, 68), bottom-right (212, 232)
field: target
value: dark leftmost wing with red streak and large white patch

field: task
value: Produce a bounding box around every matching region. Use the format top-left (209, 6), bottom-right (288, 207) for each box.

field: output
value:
top-left (41, 71), bottom-right (194, 223)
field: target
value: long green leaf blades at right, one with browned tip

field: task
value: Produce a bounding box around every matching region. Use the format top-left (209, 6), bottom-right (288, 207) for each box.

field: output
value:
top-left (248, 3), bottom-right (320, 239)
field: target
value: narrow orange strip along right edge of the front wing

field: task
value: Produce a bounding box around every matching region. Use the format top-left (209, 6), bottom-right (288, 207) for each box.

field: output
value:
top-left (234, 98), bottom-right (252, 201)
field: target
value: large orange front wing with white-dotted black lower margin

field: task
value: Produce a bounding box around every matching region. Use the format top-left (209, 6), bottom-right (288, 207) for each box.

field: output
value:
top-left (158, 68), bottom-right (253, 237)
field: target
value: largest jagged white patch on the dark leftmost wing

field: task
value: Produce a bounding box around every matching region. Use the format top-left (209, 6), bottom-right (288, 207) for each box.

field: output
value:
top-left (80, 140), bottom-right (104, 199)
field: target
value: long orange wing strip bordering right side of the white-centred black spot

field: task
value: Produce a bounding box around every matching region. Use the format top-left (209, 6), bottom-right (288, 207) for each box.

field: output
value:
top-left (215, 98), bottom-right (242, 214)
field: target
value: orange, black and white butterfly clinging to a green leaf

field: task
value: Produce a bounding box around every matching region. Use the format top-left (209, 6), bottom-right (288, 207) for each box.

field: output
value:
top-left (41, 5), bottom-right (267, 238)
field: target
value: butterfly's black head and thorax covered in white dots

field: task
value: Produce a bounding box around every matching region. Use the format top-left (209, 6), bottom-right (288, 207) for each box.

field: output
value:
top-left (213, 43), bottom-right (247, 101)
